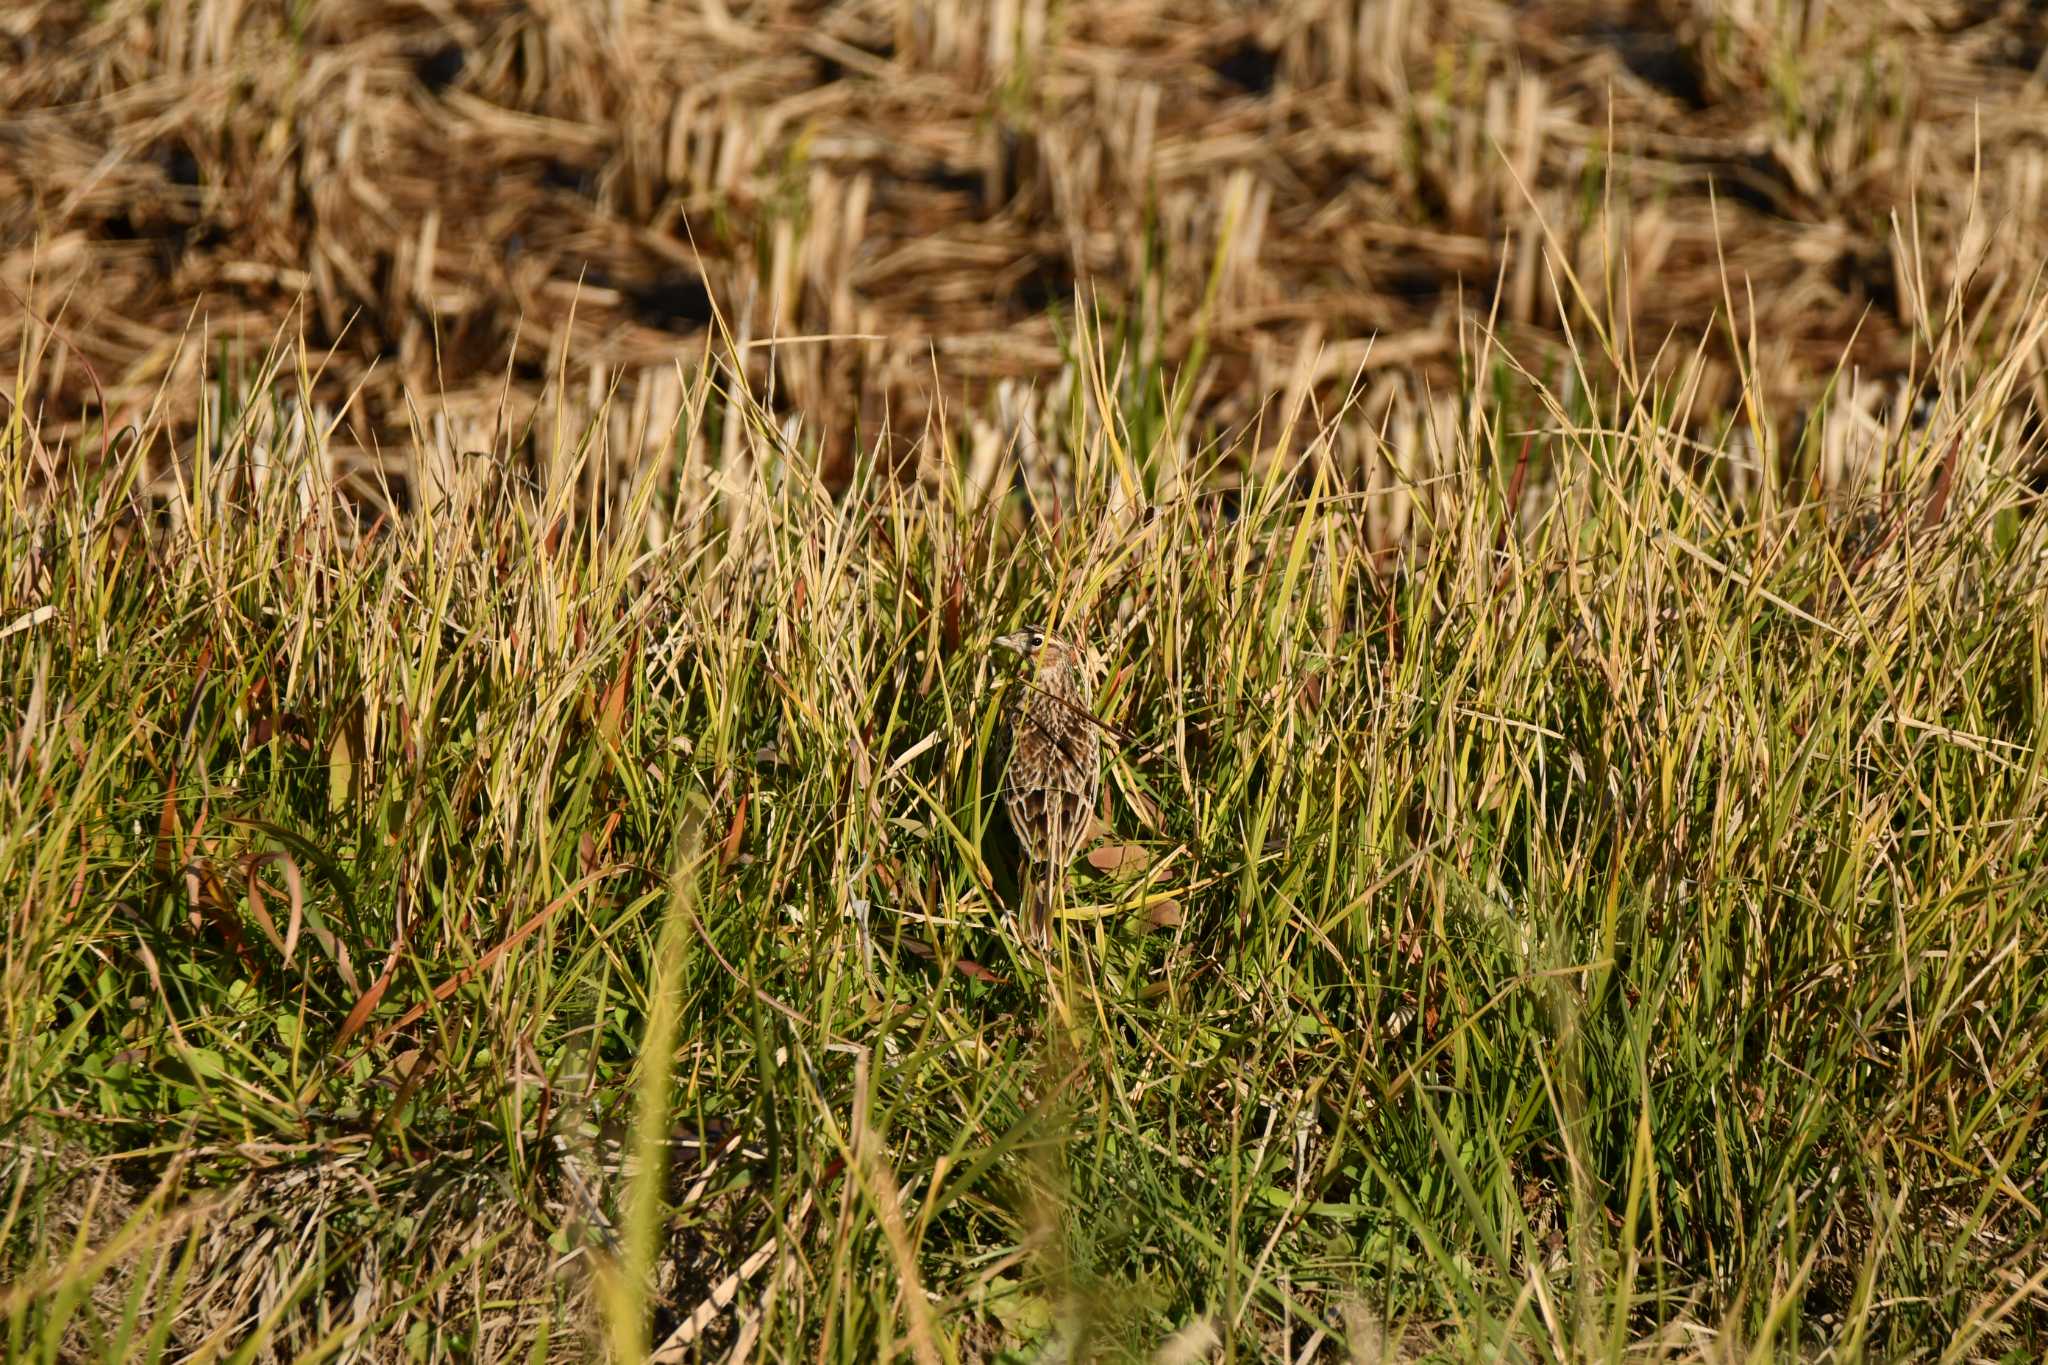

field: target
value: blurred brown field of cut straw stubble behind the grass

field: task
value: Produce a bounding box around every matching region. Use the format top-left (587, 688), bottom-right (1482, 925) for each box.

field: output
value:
top-left (0, 0), bottom-right (2048, 479)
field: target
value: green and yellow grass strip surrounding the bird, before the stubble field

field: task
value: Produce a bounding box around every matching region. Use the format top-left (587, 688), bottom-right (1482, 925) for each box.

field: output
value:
top-left (0, 261), bottom-right (2048, 1361)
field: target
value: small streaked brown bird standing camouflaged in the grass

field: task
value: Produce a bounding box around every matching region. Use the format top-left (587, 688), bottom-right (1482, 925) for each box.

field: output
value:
top-left (995, 626), bottom-right (1102, 943)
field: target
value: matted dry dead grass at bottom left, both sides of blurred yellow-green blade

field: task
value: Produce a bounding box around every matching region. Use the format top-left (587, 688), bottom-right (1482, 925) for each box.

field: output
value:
top-left (0, 1105), bottom-right (803, 1361)
